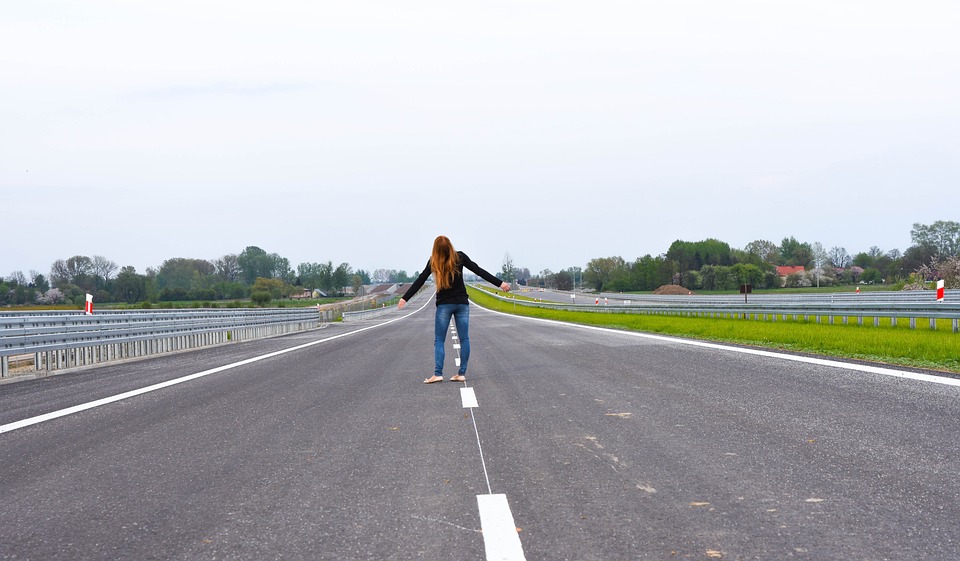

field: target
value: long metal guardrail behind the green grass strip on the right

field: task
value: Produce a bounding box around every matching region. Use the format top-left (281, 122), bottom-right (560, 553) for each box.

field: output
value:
top-left (487, 290), bottom-right (960, 333)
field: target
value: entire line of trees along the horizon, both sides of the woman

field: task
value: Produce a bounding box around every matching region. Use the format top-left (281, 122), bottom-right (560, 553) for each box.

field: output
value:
top-left (0, 221), bottom-right (960, 306)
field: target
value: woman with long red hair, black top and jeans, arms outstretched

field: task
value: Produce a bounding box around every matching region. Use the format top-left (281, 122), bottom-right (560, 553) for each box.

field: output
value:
top-left (397, 236), bottom-right (510, 384)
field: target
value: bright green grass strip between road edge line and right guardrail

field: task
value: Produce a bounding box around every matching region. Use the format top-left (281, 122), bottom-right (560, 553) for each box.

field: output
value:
top-left (470, 287), bottom-right (960, 373)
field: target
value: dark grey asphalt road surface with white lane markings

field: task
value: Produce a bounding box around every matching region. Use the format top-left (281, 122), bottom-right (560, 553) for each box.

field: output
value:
top-left (0, 295), bottom-right (960, 560)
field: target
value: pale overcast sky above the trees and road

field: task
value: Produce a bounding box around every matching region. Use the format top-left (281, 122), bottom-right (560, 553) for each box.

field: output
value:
top-left (0, 0), bottom-right (960, 276)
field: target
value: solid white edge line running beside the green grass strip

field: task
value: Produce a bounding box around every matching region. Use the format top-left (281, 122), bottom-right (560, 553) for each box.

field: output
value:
top-left (474, 304), bottom-right (960, 387)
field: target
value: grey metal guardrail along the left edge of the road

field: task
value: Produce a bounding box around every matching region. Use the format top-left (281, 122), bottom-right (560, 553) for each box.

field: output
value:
top-left (0, 308), bottom-right (323, 377)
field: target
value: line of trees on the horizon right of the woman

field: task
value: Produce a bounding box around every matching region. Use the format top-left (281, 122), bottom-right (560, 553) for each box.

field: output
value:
top-left (520, 221), bottom-right (960, 292)
